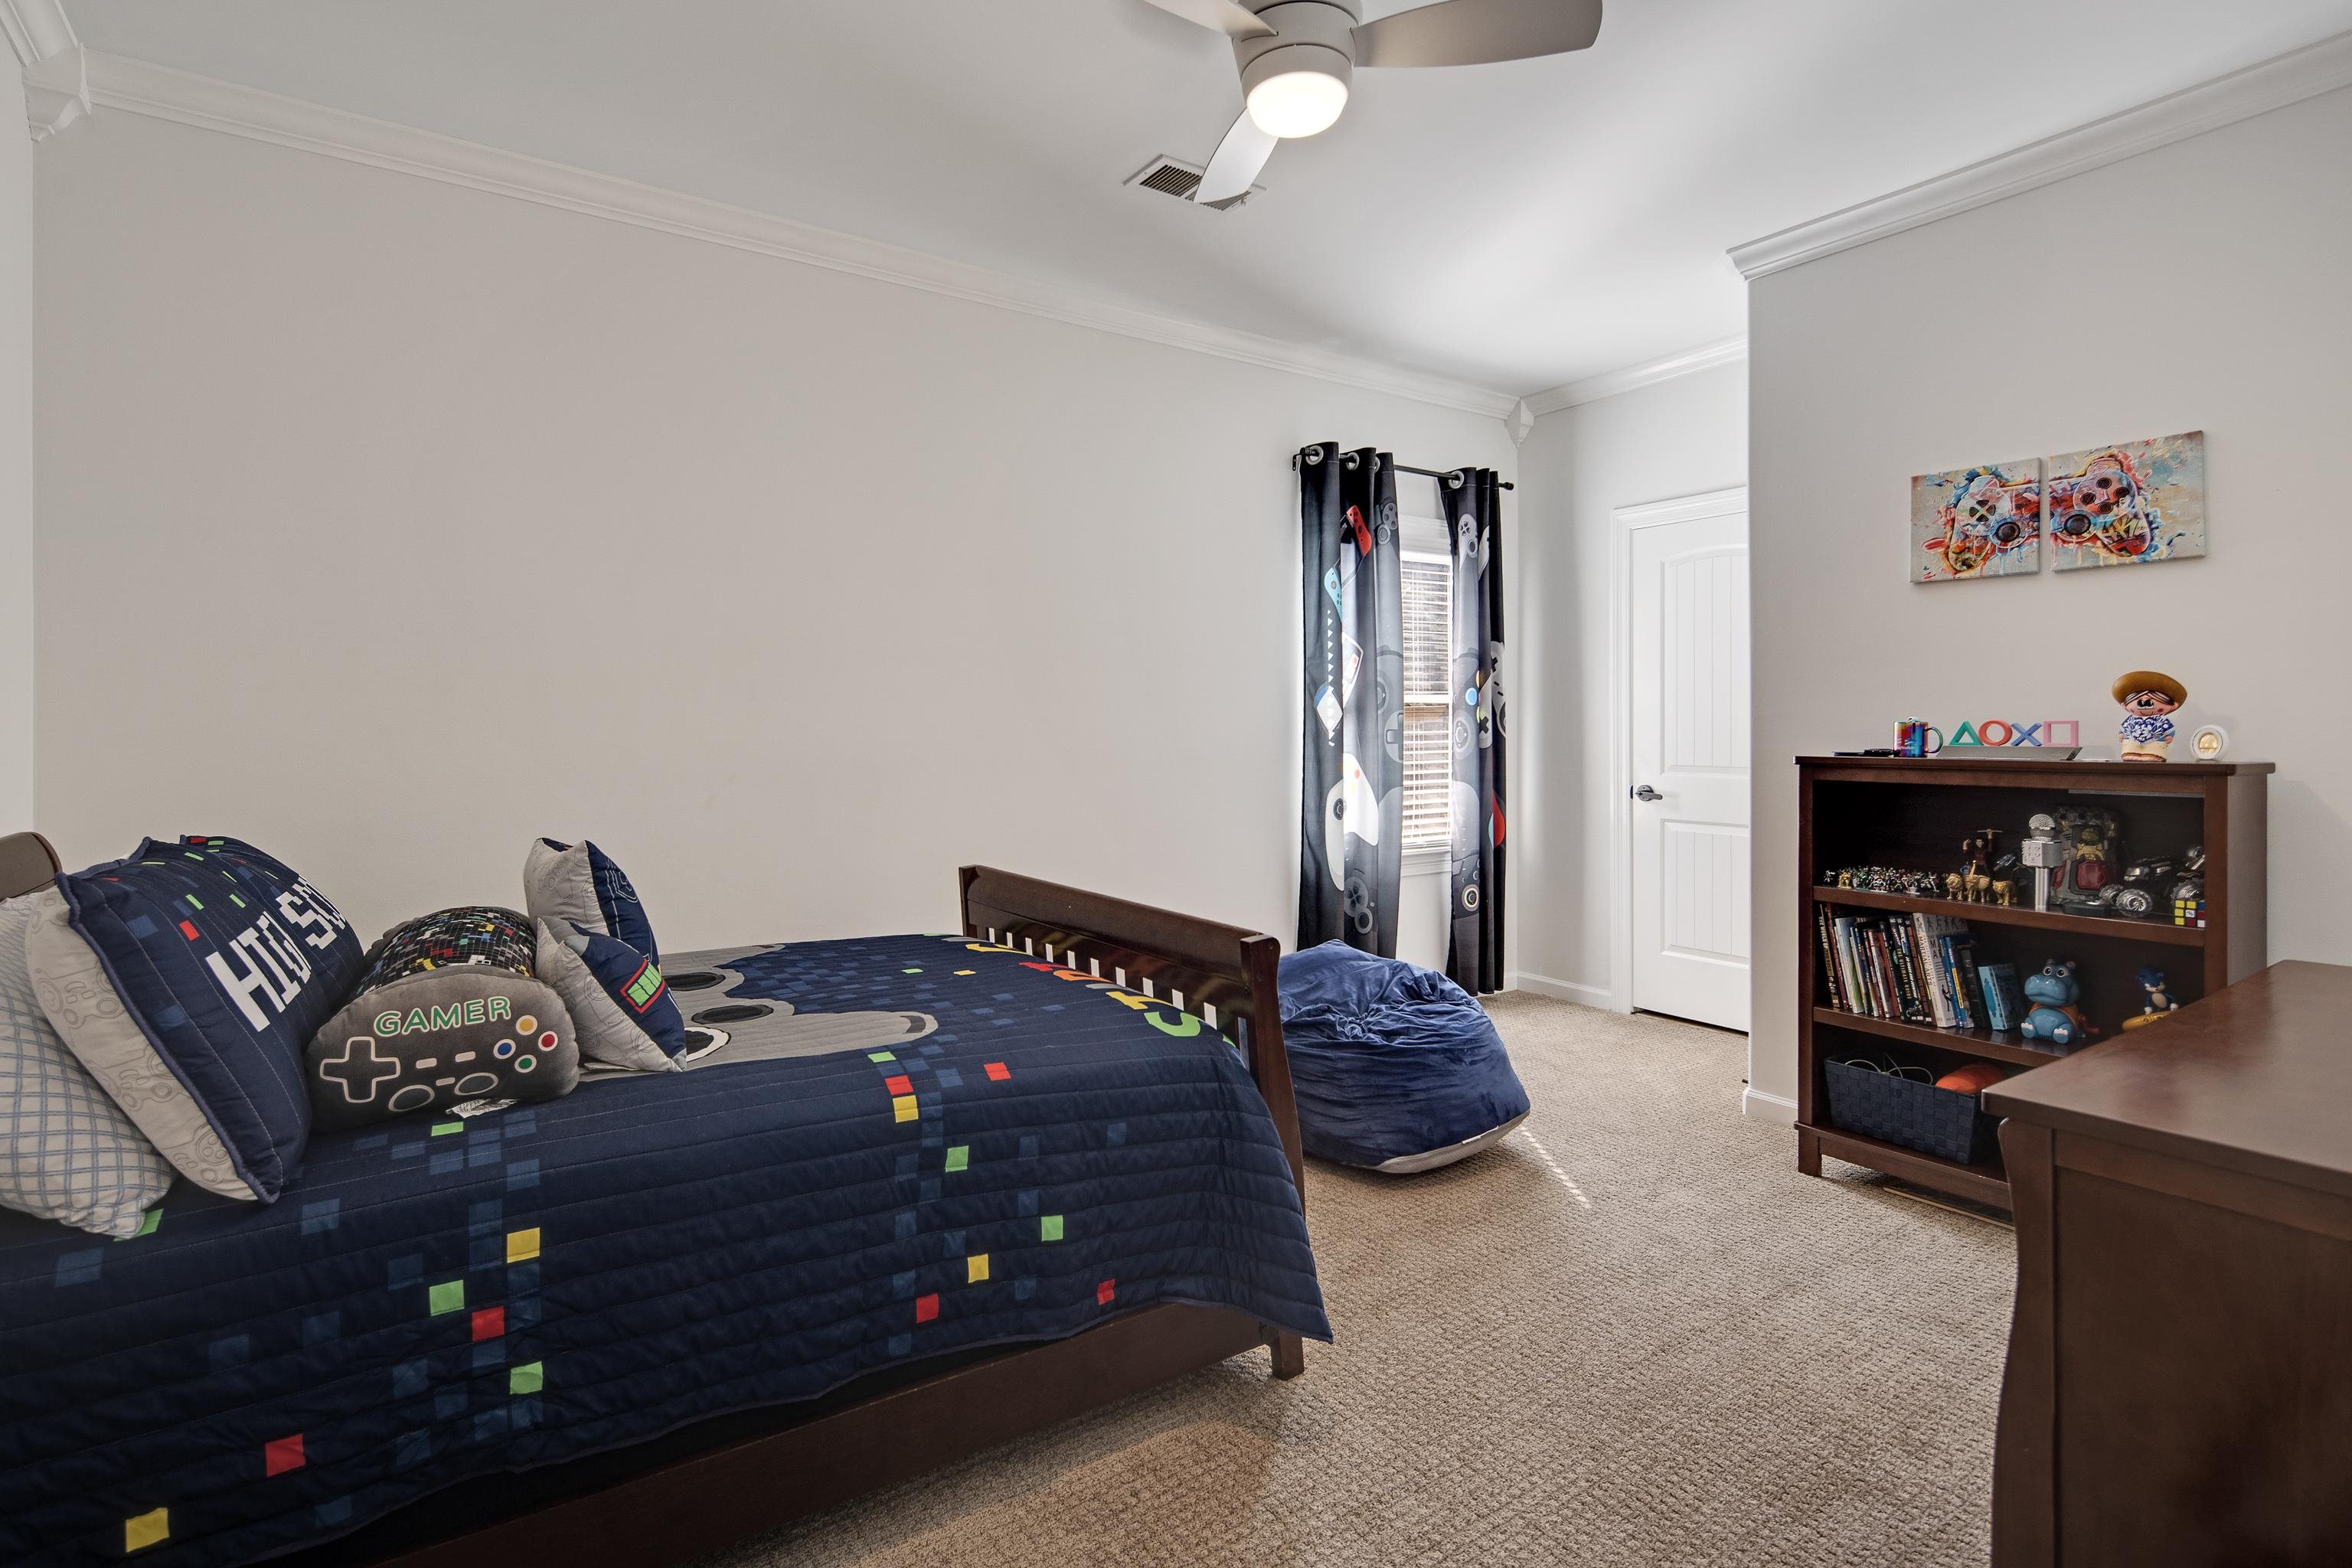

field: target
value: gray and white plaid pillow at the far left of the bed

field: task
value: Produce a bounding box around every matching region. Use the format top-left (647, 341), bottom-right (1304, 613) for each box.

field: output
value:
top-left (0, 898), bottom-right (172, 1236)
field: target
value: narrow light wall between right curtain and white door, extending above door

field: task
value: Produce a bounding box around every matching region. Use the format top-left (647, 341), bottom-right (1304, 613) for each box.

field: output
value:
top-left (1510, 364), bottom-right (1747, 1006)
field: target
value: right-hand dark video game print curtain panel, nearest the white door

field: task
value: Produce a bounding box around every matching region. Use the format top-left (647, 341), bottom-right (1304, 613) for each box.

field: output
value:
top-left (1437, 468), bottom-right (1503, 995)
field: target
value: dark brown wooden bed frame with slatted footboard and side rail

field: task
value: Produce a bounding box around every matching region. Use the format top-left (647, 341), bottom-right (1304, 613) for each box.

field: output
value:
top-left (0, 835), bottom-right (1305, 1568)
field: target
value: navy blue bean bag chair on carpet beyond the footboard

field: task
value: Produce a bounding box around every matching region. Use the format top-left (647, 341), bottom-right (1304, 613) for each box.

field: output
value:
top-left (1282, 942), bottom-right (1527, 1173)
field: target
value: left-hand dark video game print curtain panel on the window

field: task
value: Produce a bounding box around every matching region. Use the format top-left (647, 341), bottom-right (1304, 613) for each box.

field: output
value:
top-left (1298, 442), bottom-right (1404, 957)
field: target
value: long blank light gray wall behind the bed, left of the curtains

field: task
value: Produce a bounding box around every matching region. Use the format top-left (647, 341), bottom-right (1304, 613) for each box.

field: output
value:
top-left (40, 110), bottom-right (1517, 947)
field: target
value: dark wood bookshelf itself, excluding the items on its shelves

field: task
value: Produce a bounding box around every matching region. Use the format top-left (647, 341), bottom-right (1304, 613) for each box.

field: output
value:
top-left (1797, 753), bottom-right (2272, 1208)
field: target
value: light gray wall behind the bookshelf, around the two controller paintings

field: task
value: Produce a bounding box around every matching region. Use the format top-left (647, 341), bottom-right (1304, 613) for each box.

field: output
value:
top-left (1750, 92), bottom-right (2352, 1098)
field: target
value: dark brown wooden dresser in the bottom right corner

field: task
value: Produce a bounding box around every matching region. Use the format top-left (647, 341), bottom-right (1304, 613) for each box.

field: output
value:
top-left (1985, 964), bottom-right (2352, 1568)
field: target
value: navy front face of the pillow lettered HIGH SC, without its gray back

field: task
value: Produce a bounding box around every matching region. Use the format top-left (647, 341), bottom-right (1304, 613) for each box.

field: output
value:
top-left (57, 837), bottom-right (362, 1201)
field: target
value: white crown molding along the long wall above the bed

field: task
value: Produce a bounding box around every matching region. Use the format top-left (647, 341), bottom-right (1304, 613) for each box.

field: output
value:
top-left (90, 52), bottom-right (1517, 419)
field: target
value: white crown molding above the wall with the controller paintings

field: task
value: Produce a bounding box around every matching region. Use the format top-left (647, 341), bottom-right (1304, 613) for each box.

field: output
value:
top-left (1731, 33), bottom-right (2352, 279)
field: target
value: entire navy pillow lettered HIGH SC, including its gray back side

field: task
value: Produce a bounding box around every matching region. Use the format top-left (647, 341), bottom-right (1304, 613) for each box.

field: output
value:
top-left (26, 837), bottom-right (362, 1204)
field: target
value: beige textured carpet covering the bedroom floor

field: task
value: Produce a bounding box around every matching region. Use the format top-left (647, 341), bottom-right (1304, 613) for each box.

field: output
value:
top-left (687, 995), bottom-right (2014, 1568)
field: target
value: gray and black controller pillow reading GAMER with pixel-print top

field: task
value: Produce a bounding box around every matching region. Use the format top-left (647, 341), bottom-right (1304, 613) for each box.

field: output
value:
top-left (311, 905), bottom-right (581, 1129)
